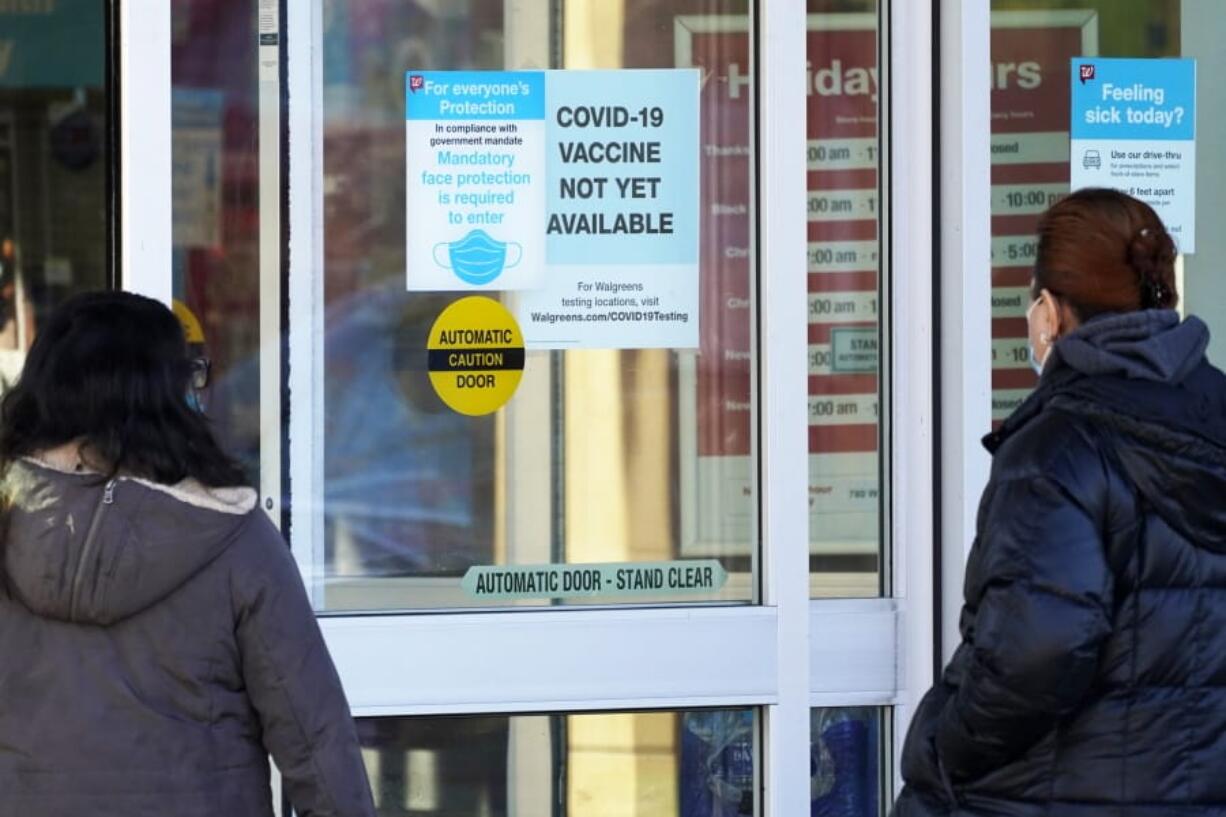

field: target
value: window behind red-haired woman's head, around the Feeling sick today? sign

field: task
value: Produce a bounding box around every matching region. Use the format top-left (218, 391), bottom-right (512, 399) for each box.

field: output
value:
top-left (992, 0), bottom-right (1226, 414)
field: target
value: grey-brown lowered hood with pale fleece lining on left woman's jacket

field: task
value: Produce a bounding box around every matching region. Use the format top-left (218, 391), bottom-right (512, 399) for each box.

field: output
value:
top-left (0, 449), bottom-right (255, 626)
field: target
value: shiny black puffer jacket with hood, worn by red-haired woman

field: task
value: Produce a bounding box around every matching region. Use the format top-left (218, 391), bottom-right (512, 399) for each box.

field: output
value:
top-left (894, 312), bottom-right (1226, 817)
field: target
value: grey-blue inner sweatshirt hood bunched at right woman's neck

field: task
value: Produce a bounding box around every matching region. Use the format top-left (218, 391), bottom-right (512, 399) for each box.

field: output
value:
top-left (1043, 309), bottom-right (1209, 383)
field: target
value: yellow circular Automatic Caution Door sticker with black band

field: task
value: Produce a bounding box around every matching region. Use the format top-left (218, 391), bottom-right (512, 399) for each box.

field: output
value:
top-left (425, 296), bottom-right (524, 417)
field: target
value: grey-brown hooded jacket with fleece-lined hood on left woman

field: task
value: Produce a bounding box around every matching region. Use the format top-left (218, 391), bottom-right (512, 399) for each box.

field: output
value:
top-left (0, 451), bottom-right (374, 817)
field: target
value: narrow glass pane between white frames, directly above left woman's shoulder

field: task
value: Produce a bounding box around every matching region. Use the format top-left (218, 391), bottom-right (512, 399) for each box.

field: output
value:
top-left (170, 0), bottom-right (268, 480)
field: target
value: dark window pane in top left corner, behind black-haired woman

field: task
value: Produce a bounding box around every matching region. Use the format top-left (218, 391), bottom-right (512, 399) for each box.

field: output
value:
top-left (0, 0), bottom-right (113, 383)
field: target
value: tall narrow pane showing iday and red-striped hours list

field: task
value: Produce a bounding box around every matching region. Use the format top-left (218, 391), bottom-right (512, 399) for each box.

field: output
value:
top-left (805, 0), bottom-right (888, 597)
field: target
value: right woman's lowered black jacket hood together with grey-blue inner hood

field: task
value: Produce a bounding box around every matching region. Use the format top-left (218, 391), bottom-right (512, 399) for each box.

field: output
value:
top-left (984, 310), bottom-right (1226, 553)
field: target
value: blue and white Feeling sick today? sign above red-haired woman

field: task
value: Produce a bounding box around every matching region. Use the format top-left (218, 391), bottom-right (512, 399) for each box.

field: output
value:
top-left (1069, 56), bottom-right (1197, 253)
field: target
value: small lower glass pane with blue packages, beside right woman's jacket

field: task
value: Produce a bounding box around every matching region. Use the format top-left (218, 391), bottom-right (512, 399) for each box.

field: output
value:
top-left (809, 707), bottom-right (891, 817)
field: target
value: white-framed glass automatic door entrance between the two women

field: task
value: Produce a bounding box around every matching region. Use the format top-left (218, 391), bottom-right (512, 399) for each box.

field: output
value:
top-left (136, 0), bottom-right (932, 817)
